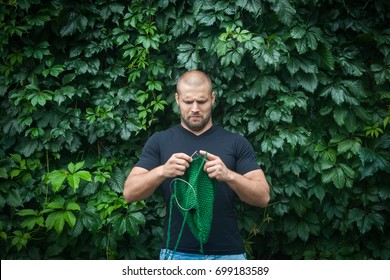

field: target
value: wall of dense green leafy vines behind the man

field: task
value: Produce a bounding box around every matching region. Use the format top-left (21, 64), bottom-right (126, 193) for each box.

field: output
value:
top-left (0, 0), bottom-right (390, 259)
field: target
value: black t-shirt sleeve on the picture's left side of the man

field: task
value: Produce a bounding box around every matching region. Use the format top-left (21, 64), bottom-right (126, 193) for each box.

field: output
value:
top-left (135, 132), bottom-right (161, 170)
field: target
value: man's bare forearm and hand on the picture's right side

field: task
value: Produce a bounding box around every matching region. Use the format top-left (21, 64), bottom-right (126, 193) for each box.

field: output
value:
top-left (200, 151), bottom-right (270, 207)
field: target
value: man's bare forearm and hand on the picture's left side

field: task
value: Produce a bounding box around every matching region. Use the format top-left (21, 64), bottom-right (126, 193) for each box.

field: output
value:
top-left (123, 153), bottom-right (192, 203)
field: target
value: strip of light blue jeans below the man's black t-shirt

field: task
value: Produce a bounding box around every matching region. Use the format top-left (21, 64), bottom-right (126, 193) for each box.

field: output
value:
top-left (160, 249), bottom-right (246, 260)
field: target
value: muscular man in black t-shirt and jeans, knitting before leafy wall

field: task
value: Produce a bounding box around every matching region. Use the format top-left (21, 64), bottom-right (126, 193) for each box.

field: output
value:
top-left (123, 70), bottom-right (270, 259)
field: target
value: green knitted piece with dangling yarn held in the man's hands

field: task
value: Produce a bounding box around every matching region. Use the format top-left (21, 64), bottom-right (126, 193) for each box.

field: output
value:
top-left (166, 155), bottom-right (217, 254)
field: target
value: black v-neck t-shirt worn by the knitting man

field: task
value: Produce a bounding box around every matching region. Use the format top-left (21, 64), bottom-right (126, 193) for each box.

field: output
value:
top-left (136, 125), bottom-right (260, 255)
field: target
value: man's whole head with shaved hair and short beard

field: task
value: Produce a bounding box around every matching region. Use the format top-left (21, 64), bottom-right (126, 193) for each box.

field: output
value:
top-left (175, 70), bottom-right (215, 134)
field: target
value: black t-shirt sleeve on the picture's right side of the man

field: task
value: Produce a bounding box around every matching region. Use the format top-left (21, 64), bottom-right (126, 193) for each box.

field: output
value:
top-left (236, 137), bottom-right (260, 175)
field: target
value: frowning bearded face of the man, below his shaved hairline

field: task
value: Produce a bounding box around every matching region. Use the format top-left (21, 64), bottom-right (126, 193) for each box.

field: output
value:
top-left (175, 83), bottom-right (215, 132)
